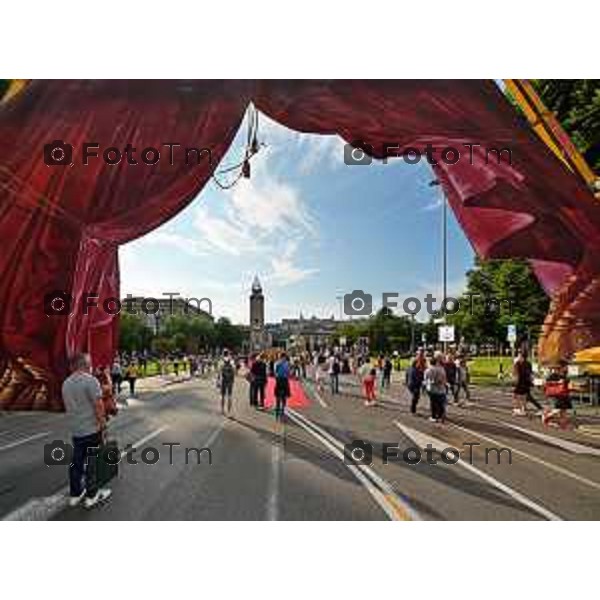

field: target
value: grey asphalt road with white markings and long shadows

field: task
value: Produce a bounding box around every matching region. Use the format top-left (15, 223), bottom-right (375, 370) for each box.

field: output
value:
top-left (0, 376), bottom-right (600, 520)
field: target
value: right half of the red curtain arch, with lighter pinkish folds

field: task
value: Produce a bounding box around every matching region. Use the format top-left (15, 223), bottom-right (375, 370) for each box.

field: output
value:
top-left (255, 80), bottom-right (600, 359)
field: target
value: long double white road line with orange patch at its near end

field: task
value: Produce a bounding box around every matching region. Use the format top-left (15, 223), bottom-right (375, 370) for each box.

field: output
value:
top-left (288, 408), bottom-right (420, 521)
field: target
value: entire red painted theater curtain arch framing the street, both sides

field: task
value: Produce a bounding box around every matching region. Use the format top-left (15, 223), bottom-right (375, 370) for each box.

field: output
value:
top-left (0, 80), bottom-right (600, 409)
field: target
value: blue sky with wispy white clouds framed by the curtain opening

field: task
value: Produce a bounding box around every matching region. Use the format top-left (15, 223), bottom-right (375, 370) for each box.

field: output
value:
top-left (120, 115), bottom-right (473, 323)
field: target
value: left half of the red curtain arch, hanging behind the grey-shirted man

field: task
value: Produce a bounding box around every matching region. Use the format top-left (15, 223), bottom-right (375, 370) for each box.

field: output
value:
top-left (0, 81), bottom-right (249, 409)
